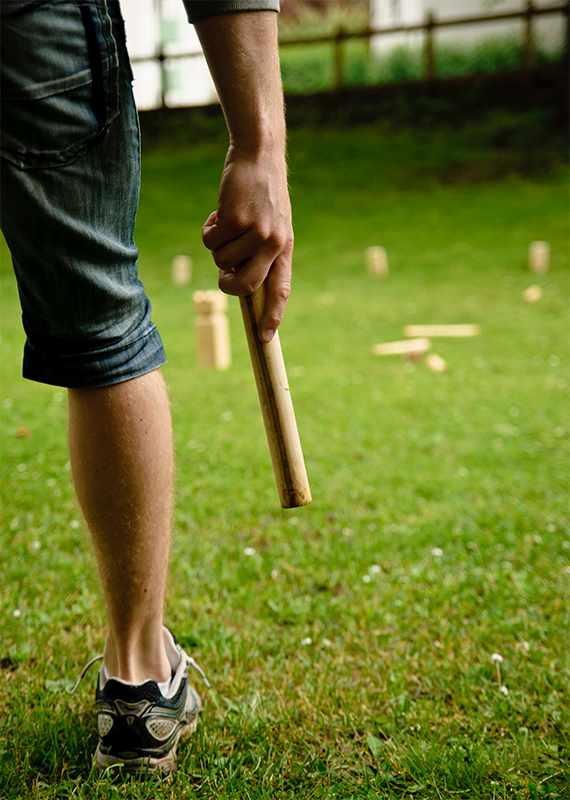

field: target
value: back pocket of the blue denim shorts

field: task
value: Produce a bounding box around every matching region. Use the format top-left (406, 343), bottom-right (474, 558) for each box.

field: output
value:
top-left (0, 0), bottom-right (119, 169)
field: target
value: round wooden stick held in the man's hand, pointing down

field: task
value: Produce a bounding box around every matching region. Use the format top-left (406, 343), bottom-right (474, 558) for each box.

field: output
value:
top-left (240, 286), bottom-right (312, 508)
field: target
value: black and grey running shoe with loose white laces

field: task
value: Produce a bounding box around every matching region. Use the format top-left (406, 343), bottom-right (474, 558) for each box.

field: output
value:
top-left (94, 628), bottom-right (210, 776)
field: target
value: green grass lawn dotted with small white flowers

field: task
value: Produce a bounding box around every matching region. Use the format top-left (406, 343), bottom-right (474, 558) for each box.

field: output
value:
top-left (0, 114), bottom-right (570, 800)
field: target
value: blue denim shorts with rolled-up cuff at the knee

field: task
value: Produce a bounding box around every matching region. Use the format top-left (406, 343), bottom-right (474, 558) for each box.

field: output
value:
top-left (0, 0), bottom-right (166, 388)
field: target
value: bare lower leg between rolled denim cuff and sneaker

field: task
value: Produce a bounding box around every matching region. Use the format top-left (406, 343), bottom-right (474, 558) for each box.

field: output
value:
top-left (68, 370), bottom-right (173, 683)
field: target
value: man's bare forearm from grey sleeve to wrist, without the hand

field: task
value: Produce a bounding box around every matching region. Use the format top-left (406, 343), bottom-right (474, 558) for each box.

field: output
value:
top-left (195, 11), bottom-right (285, 154)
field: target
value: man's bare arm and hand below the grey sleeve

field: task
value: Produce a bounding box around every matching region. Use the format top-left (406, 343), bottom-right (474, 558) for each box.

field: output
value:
top-left (195, 11), bottom-right (293, 341)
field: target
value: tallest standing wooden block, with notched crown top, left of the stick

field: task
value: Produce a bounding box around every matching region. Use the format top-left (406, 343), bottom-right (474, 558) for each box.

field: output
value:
top-left (193, 290), bottom-right (232, 369)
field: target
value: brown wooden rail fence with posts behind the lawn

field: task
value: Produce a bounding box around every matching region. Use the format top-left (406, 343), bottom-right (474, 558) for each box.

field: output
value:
top-left (133, 0), bottom-right (570, 105)
